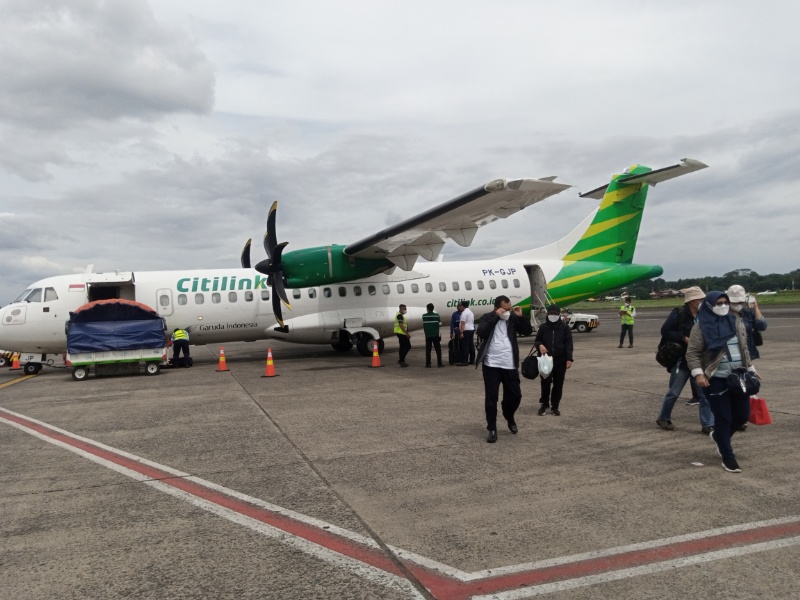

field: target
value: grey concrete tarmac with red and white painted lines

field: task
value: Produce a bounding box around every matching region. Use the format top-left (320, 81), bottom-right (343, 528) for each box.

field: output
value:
top-left (0, 305), bottom-right (800, 600)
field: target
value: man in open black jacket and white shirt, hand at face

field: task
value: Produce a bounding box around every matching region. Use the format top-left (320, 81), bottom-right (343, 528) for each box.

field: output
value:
top-left (475, 296), bottom-right (533, 444)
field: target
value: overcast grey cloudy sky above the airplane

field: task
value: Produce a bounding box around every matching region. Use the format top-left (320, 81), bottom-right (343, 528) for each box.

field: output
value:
top-left (0, 0), bottom-right (800, 304)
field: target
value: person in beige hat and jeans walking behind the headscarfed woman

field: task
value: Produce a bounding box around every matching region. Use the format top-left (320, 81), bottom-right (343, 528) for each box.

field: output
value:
top-left (656, 286), bottom-right (714, 434)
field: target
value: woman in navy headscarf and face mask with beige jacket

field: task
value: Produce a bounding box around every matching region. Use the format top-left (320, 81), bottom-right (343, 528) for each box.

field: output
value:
top-left (686, 292), bottom-right (758, 473)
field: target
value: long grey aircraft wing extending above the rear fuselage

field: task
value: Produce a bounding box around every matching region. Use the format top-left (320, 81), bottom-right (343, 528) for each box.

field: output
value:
top-left (344, 177), bottom-right (571, 271)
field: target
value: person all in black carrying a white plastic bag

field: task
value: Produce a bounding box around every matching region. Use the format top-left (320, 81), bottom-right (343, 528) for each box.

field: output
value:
top-left (533, 304), bottom-right (572, 417)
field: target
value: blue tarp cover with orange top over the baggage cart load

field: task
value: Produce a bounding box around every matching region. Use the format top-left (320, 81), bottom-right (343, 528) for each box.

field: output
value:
top-left (67, 300), bottom-right (166, 354)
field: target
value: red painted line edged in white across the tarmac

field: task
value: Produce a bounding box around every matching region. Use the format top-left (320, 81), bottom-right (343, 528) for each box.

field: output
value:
top-left (0, 409), bottom-right (800, 600)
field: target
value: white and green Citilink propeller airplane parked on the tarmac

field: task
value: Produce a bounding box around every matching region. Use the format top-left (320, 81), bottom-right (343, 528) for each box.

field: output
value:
top-left (0, 158), bottom-right (707, 374)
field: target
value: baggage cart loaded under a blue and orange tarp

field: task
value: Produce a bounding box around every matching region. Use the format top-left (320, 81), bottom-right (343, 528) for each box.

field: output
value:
top-left (67, 299), bottom-right (167, 381)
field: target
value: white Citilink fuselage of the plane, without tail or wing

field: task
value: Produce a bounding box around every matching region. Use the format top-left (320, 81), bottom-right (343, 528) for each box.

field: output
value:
top-left (0, 259), bottom-right (563, 360)
